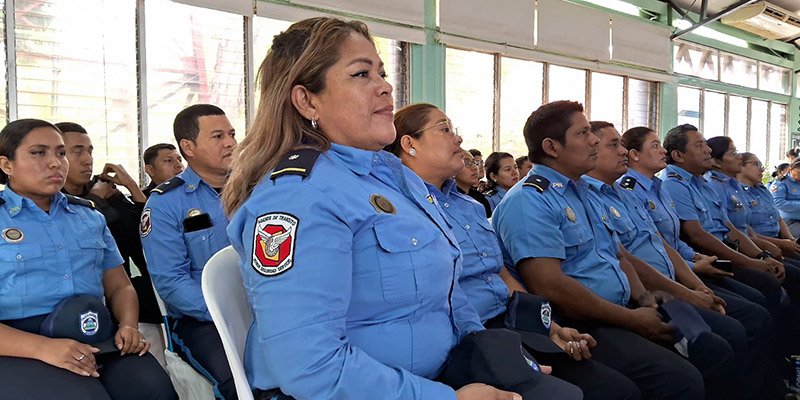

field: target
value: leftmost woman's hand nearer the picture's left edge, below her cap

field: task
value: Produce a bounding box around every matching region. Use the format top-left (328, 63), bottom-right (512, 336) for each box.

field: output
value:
top-left (37, 338), bottom-right (100, 376)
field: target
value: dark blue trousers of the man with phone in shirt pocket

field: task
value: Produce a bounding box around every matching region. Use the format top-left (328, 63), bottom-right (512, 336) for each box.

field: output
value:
top-left (170, 317), bottom-right (238, 400)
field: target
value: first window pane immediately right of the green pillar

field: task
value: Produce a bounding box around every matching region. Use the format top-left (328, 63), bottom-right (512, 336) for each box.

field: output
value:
top-left (445, 49), bottom-right (494, 154)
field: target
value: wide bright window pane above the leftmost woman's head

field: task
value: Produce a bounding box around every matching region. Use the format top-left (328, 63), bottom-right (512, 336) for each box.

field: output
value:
top-left (14, 0), bottom-right (139, 177)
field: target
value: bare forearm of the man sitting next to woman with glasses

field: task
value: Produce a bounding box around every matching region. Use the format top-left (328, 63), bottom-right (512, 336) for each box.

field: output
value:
top-left (517, 258), bottom-right (630, 326)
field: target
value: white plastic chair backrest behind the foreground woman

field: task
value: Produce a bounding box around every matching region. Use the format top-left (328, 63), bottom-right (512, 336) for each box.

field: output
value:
top-left (201, 246), bottom-right (253, 400)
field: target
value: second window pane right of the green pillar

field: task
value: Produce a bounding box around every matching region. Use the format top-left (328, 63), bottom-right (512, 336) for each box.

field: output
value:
top-left (500, 57), bottom-right (544, 157)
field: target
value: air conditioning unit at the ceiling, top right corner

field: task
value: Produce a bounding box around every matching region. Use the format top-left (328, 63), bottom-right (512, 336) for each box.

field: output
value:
top-left (720, 1), bottom-right (800, 40)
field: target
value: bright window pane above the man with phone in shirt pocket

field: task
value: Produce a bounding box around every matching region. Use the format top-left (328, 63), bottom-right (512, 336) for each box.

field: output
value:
top-left (144, 0), bottom-right (245, 145)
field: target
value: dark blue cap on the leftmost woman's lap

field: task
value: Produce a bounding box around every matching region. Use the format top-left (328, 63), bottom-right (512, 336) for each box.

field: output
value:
top-left (40, 295), bottom-right (119, 354)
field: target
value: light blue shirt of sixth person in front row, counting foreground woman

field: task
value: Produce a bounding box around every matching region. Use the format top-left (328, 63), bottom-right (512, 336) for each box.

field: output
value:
top-left (661, 164), bottom-right (729, 240)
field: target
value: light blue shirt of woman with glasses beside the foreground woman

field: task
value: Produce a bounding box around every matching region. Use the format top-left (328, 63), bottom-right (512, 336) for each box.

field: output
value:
top-left (426, 179), bottom-right (508, 323)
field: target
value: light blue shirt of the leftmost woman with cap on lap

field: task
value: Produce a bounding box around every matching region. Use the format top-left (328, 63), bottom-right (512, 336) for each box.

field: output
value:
top-left (0, 187), bottom-right (122, 320)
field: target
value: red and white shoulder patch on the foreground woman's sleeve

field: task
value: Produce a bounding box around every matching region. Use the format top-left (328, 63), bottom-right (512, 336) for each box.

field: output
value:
top-left (251, 213), bottom-right (299, 276)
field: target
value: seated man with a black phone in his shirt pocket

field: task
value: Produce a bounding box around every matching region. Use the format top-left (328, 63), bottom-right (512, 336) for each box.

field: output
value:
top-left (139, 104), bottom-right (236, 400)
